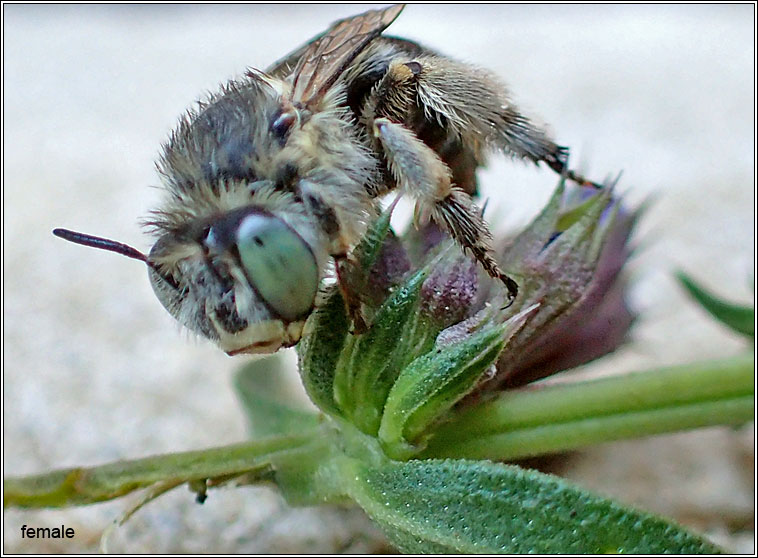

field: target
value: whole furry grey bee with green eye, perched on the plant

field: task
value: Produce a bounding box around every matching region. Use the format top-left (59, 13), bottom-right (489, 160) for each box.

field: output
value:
top-left (53, 6), bottom-right (597, 355)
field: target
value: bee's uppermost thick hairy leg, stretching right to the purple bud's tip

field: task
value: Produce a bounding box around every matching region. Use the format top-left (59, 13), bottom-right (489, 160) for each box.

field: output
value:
top-left (407, 56), bottom-right (602, 188)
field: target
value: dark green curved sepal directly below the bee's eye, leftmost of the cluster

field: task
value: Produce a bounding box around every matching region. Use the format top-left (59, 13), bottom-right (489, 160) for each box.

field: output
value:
top-left (297, 286), bottom-right (350, 416)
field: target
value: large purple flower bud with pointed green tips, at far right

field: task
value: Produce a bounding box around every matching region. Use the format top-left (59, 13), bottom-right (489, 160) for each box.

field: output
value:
top-left (483, 185), bottom-right (638, 391)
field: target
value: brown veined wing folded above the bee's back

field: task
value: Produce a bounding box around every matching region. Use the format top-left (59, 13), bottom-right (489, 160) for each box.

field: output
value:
top-left (286, 4), bottom-right (404, 105)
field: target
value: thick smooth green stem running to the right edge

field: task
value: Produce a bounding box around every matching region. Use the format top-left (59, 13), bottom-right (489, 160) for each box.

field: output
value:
top-left (421, 355), bottom-right (754, 460)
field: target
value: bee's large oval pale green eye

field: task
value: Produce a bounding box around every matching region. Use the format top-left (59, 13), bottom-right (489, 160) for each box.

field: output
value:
top-left (237, 214), bottom-right (319, 320)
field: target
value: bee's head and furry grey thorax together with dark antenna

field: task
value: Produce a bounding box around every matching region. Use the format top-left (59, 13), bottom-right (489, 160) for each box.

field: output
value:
top-left (56, 65), bottom-right (374, 355)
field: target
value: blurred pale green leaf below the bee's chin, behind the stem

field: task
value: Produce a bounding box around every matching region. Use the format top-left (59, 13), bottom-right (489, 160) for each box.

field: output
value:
top-left (234, 355), bottom-right (319, 439)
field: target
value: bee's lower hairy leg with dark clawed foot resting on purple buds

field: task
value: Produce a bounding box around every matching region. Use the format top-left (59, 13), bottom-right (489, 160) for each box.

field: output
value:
top-left (373, 118), bottom-right (518, 302)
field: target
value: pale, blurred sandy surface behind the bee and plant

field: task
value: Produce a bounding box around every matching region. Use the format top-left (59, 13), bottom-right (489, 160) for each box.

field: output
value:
top-left (3, 5), bottom-right (755, 553)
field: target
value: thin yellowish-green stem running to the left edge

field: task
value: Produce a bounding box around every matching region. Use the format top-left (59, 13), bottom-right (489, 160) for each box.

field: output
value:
top-left (3, 435), bottom-right (313, 508)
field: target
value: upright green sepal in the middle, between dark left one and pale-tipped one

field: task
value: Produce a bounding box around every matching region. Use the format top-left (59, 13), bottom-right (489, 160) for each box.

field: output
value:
top-left (334, 269), bottom-right (427, 435)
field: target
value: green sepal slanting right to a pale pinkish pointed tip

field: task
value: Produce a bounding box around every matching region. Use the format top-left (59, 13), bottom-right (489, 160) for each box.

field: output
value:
top-left (379, 307), bottom-right (534, 459)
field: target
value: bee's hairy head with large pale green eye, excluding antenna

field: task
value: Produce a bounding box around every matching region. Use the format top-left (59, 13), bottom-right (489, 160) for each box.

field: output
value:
top-left (148, 206), bottom-right (326, 355)
